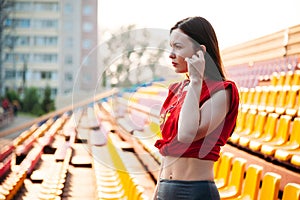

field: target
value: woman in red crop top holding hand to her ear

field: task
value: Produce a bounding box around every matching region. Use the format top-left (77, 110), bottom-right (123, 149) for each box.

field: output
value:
top-left (154, 17), bottom-right (239, 200)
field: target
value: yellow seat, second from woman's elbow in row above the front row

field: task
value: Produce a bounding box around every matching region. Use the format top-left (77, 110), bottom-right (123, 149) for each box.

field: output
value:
top-left (239, 112), bottom-right (267, 147)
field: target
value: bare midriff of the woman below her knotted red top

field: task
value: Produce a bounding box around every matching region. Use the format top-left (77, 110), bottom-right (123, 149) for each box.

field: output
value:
top-left (160, 156), bottom-right (214, 181)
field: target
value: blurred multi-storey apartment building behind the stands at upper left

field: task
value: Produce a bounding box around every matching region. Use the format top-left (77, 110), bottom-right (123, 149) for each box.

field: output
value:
top-left (1, 0), bottom-right (98, 101)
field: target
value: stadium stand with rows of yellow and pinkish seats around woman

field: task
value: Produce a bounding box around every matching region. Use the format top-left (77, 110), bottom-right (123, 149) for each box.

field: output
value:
top-left (0, 26), bottom-right (300, 200)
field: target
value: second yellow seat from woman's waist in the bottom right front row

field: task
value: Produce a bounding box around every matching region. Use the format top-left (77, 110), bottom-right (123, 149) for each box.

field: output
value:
top-left (219, 158), bottom-right (247, 199)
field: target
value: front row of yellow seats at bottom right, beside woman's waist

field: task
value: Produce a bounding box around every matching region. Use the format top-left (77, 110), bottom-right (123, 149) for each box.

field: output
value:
top-left (214, 152), bottom-right (300, 200)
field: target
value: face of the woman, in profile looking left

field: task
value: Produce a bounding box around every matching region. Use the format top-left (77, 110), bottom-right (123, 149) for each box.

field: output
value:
top-left (169, 29), bottom-right (195, 73)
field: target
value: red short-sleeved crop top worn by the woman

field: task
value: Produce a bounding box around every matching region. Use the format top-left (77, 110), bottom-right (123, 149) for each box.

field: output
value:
top-left (154, 80), bottom-right (239, 161)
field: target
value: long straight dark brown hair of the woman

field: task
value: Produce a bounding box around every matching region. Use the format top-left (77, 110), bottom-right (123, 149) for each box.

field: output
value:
top-left (170, 17), bottom-right (226, 81)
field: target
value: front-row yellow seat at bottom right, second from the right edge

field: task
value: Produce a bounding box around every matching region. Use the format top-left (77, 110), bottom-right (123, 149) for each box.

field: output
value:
top-left (259, 172), bottom-right (281, 200)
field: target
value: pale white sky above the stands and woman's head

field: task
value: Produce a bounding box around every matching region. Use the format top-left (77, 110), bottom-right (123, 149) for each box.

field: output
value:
top-left (98, 0), bottom-right (300, 50)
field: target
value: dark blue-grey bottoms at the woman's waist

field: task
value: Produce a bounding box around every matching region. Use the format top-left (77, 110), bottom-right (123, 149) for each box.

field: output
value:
top-left (157, 179), bottom-right (220, 200)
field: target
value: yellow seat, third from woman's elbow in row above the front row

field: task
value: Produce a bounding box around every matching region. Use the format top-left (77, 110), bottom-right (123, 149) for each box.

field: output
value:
top-left (249, 113), bottom-right (279, 151)
